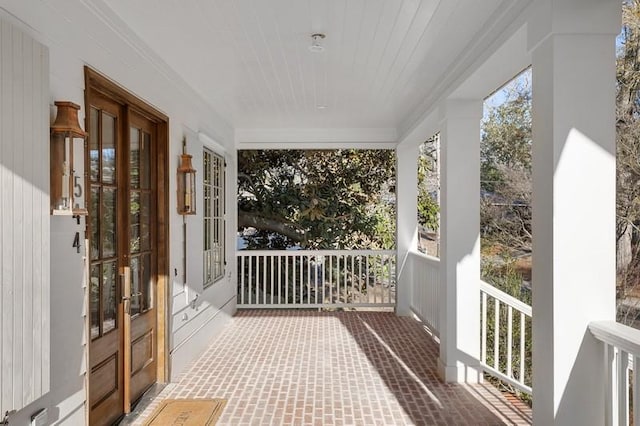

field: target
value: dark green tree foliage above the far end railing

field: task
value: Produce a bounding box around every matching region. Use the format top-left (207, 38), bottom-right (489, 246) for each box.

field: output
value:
top-left (238, 150), bottom-right (395, 249)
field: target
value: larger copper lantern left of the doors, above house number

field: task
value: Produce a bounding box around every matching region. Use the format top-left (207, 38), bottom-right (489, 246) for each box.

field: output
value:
top-left (50, 101), bottom-right (87, 216)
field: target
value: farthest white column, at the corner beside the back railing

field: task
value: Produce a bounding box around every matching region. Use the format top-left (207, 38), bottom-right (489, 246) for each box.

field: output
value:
top-left (396, 142), bottom-right (419, 316)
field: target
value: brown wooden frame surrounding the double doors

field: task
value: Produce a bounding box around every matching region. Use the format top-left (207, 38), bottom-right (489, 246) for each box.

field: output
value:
top-left (84, 66), bottom-right (171, 406)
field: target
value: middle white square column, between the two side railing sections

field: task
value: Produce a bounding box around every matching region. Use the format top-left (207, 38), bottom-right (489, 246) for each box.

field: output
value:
top-left (438, 100), bottom-right (482, 383)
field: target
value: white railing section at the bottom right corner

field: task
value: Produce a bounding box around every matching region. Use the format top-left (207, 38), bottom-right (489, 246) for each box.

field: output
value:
top-left (589, 321), bottom-right (640, 425)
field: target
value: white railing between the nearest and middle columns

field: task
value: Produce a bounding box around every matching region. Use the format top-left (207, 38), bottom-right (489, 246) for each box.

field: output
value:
top-left (480, 281), bottom-right (532, 394)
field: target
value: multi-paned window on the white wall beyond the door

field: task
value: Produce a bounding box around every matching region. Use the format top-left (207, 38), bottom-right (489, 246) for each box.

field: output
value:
top-left (202, 148), bottom-right (226, 287)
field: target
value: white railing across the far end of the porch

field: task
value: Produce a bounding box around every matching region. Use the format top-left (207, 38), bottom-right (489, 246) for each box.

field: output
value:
top-left (236, 250), bottom-right (396, 308)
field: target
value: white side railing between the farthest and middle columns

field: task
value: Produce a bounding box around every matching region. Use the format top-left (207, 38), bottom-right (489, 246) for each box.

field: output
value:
top-left (409, 251), bottom-right (442, 336)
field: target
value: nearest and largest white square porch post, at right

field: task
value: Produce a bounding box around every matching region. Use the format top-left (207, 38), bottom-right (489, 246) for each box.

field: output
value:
top-left (529, 0), bottom-right (621, 425)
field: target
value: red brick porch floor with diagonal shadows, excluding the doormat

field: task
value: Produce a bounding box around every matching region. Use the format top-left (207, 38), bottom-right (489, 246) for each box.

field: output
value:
top-left (133, 311), bottom-right (531, 426)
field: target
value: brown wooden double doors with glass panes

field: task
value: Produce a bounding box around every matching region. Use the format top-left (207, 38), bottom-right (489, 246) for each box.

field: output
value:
top-left (87, 93), bottom-right (159, 425)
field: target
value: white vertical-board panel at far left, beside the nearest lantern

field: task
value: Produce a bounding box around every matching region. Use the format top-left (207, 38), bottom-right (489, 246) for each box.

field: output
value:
top-left (0, 20), bottom-right (50, 418)
